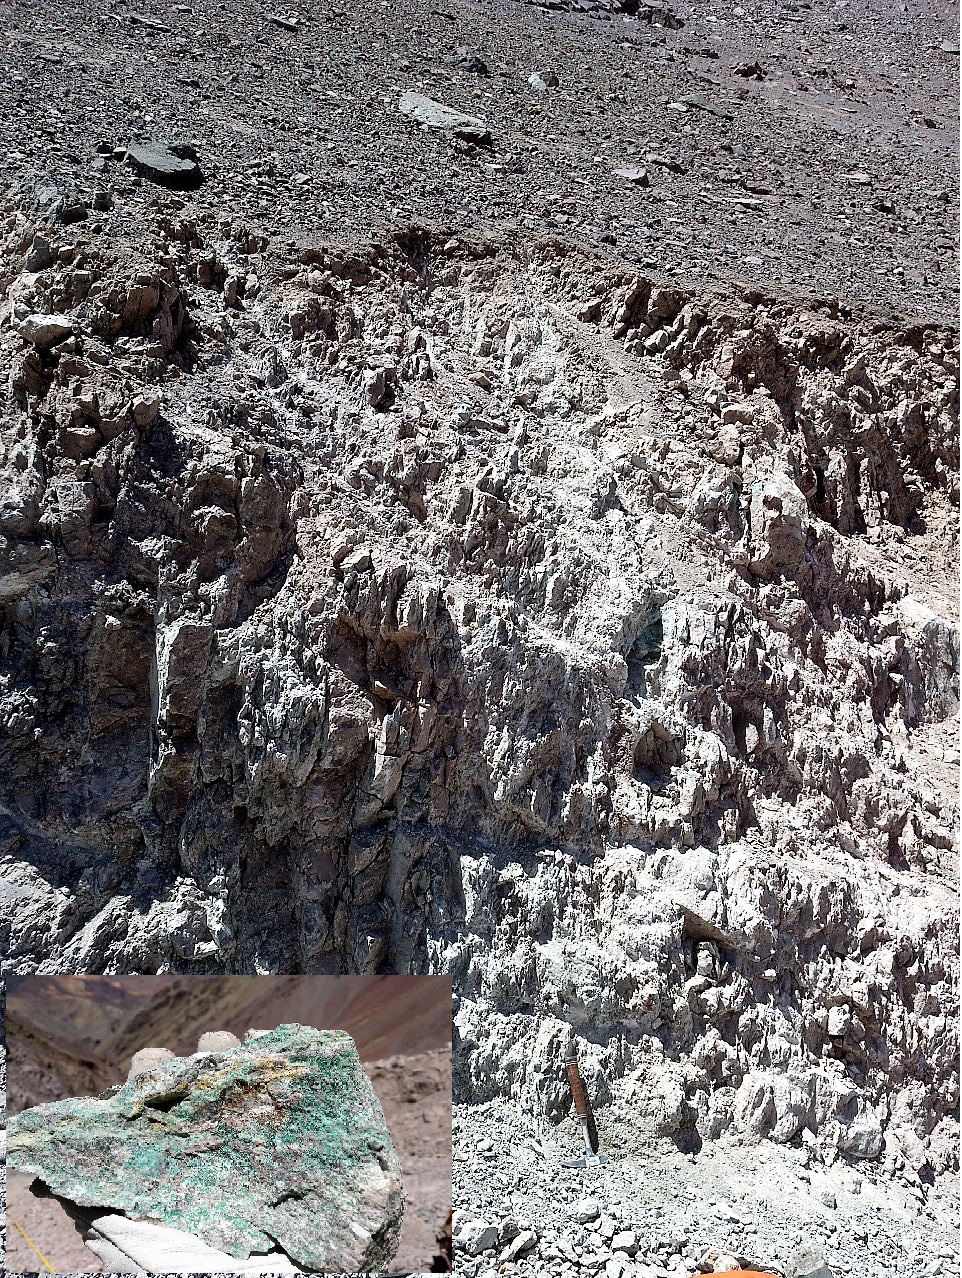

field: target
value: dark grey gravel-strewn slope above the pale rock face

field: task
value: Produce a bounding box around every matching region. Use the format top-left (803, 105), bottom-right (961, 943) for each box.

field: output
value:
top-left (0, 0), bottom-right (958, 324)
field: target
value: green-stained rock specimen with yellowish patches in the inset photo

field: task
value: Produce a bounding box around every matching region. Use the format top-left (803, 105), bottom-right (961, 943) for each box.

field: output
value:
top-left (6, 1025), bottom-right (404, 1273)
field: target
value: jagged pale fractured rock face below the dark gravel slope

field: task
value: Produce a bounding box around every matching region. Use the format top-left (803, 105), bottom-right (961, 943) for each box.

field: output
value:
top-left (0, 215), bottom-right (958, 1174)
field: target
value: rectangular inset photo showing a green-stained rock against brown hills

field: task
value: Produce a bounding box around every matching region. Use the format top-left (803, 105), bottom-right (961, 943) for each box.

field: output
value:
top-left (5, 976), bottom-right (451, 1274)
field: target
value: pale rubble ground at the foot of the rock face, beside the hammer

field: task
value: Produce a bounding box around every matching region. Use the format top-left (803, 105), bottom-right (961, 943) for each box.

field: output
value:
top-left (455, 1102), bottom-right (958, 1278)
